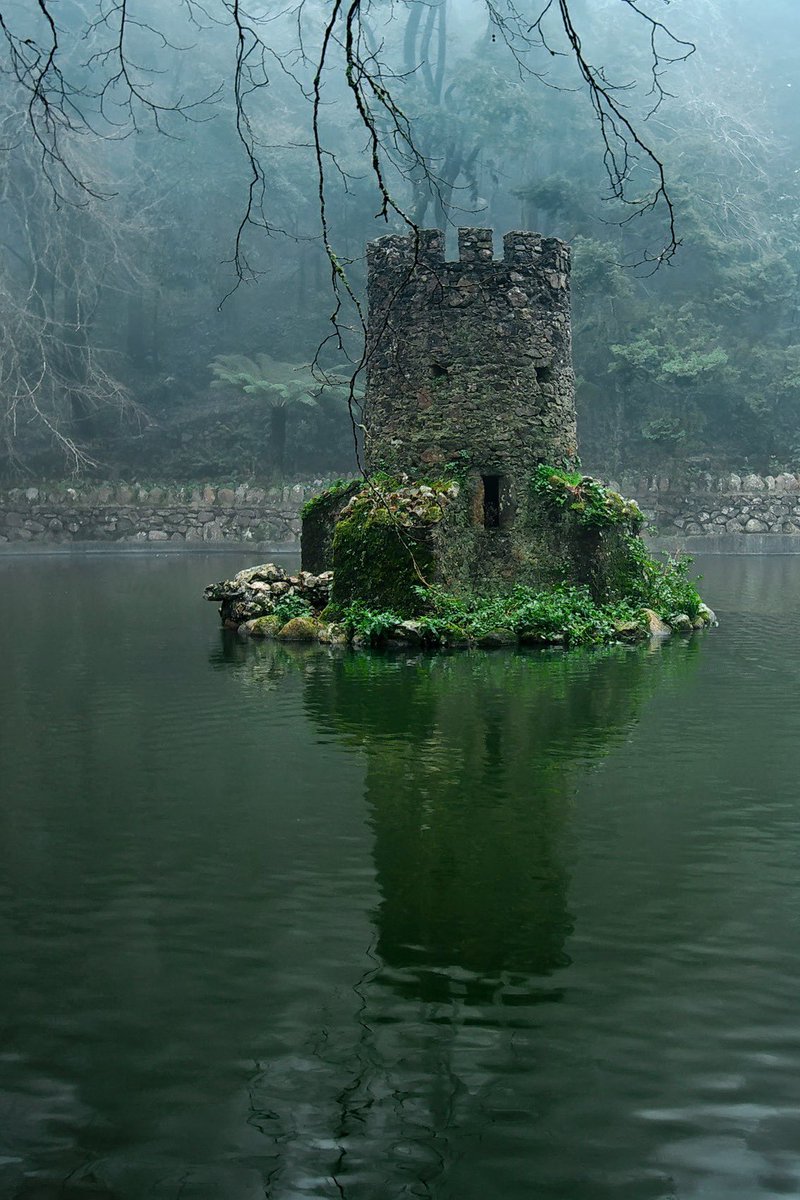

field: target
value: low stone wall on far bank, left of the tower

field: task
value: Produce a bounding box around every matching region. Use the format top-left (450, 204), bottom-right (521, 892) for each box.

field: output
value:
top-left (0, 480), bottom-right (325, 550)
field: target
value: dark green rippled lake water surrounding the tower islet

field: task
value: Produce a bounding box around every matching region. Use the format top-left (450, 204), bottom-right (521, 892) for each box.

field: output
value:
top-left (0, 554), bottom-right (800, 1200)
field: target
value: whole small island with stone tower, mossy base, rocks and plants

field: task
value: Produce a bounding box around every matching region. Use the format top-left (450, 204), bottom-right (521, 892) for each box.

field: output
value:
top-left (205, 229), bottom-right (716, 648)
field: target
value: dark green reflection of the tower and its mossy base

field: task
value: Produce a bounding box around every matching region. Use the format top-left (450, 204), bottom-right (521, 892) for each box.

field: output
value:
top-left (305, 647), bottom-right (690, 1003)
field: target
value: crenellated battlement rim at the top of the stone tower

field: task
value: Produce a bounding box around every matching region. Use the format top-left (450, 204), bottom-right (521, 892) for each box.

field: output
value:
top-left (367, 227), bottom-right (570, 287)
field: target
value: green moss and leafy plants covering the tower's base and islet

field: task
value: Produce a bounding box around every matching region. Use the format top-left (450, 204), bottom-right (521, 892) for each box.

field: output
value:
top-left (325, 464), bottom-right (702, 646)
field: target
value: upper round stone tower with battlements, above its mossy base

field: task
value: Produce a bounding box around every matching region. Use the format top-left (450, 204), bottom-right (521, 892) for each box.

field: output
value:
top-left (365, 229), bottom-right (577, 504)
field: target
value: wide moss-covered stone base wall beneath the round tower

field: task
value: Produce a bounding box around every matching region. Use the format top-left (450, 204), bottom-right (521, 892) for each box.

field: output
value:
top-left (303, 476), bottom-right (639, 617)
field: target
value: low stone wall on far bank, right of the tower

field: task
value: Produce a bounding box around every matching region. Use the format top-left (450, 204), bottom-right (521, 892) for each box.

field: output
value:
top-left (612, 474), bottom-right (800, 538)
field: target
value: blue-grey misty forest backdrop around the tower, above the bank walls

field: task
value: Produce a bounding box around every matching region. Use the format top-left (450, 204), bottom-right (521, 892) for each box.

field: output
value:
top-left (0, 0), bottom-right (800, 481)
